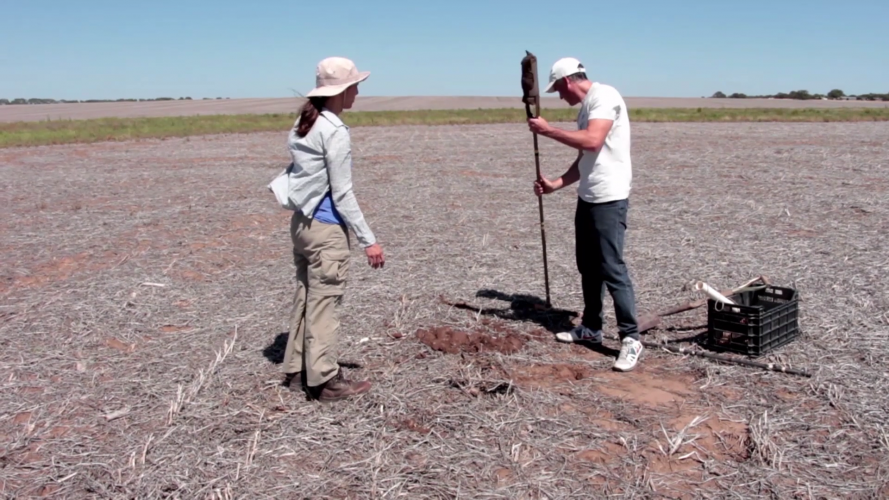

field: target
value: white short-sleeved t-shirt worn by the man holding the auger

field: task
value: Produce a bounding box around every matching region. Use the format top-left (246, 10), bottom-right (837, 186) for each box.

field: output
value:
top-left (577, 82), bottom-right (633, 203)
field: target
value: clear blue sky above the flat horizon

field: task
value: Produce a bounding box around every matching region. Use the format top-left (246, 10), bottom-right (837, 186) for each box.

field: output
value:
top-left (0, 0), bottom-right (889, 99)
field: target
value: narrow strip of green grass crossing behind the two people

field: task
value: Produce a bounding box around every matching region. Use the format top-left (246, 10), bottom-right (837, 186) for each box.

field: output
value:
top-left (0, 107), bottom-right (889, 148)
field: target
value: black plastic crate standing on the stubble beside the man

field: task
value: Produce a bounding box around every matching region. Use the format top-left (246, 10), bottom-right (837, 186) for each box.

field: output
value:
top-left (707, 286), bottom-right (800, 357)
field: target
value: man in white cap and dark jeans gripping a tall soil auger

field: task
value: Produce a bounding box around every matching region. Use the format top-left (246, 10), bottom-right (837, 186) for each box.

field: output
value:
top-left (528, 57), bottom-right (642, 371)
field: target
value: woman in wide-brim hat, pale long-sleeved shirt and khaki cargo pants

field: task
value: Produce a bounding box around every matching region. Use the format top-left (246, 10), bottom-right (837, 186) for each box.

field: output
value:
top-left (283, 57), bottom-right (384, 401)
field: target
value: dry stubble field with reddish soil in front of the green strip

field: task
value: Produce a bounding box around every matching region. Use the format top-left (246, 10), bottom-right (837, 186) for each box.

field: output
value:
top-left (0, 123), bottom-right (889, 499)
